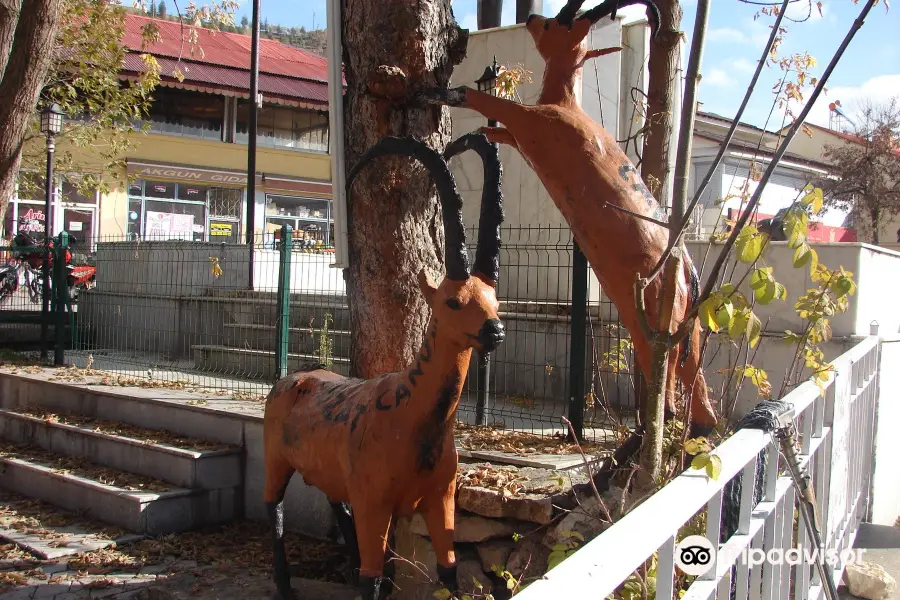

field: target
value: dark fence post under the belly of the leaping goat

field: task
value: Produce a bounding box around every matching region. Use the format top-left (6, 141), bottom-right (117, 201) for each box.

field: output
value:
top-left (569, 239), bottom-right (588, 440)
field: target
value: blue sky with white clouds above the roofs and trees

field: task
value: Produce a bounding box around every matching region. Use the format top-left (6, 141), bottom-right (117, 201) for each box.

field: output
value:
top-left (237, 0), bottom-right (900, 128)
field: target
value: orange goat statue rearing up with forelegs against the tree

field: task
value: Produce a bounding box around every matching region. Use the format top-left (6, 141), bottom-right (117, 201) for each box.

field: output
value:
top-left (418, 0), bottom-right (716, 435)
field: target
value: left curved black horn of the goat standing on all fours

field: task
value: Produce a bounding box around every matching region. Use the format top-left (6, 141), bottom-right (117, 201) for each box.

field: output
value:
top-left (347, 137), bottom-right (469, 281)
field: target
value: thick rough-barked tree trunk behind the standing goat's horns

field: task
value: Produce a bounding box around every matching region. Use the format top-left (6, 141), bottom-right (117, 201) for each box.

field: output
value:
top-left (343, 0), bottom-right (467, 377)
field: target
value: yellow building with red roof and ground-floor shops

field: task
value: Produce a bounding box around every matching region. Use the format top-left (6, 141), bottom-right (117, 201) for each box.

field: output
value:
top-left (3, 13), bottom-right (333, 246)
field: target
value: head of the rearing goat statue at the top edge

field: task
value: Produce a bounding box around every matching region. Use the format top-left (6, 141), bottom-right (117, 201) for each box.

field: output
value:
top-left (525, 0), bottom-right (660, 68)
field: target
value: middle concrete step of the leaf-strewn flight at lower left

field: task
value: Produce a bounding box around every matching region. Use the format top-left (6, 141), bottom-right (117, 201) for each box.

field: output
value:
top-left (0, 409), bottom-right (241, 490)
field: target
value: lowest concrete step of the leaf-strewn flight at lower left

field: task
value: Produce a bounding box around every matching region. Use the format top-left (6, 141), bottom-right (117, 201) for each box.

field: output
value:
top-left (0, 444), bottom-right (241, 535)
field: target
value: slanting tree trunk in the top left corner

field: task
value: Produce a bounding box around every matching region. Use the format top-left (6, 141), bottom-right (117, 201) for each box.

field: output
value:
top-left (0, 0), bottom-right (62, 221)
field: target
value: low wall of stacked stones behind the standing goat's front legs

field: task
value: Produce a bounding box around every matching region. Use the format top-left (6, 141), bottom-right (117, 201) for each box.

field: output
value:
top-left (392, 463), bottom-right (622, 600)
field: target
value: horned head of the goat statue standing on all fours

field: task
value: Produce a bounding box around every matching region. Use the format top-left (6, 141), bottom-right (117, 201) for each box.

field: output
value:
top-left (347, 133), bottom-right (505, 352)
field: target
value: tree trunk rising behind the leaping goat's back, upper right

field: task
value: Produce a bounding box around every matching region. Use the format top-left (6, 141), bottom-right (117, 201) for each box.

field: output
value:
top-left (641, 0), bottom-right (681, 207)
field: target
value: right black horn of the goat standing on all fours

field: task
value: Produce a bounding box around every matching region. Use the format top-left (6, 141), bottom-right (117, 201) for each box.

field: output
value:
top-left (444, 133), bottom-right (503, 283)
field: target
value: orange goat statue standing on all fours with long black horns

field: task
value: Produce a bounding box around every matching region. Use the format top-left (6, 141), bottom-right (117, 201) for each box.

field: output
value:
top-left (264, 133), bottom-right (504, 600)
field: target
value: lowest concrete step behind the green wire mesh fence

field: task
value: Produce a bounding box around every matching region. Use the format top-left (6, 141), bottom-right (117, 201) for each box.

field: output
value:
top-left (191, 345), bottom-right (350, 381)
